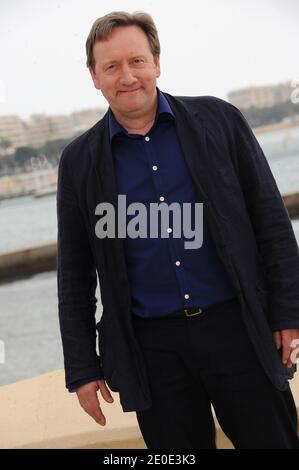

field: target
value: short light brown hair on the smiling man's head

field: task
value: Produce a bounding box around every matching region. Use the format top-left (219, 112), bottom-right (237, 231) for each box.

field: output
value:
top-left (86, 11), bottom-right (160, 70)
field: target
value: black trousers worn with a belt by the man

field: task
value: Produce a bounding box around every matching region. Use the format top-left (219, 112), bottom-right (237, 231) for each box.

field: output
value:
top-left (133, 300), bottom-right (299, 449)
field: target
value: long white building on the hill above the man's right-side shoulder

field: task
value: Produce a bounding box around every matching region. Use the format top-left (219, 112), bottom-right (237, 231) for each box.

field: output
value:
top-left (227, 82), bottom-right (294, 109)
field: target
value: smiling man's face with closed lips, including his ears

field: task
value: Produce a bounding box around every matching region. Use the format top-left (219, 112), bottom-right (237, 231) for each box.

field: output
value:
top-left (90, 26), bottom-right (160, 117)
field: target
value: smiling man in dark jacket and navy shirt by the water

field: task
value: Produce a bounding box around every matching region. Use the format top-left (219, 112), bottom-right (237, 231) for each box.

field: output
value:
top-left (57, 12), bottom-right (299, 449)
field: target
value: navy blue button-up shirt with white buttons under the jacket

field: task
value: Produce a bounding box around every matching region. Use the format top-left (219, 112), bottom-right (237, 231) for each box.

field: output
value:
top-left (70, 88), bottom-right (236, 391)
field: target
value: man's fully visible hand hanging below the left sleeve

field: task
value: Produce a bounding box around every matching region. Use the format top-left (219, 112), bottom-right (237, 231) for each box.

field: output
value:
top-left (76, 380), bottom-right (114, 426)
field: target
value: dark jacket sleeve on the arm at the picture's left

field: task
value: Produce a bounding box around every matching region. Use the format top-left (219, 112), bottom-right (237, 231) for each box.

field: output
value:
top-left (57, 149), bottom-right (103, 387)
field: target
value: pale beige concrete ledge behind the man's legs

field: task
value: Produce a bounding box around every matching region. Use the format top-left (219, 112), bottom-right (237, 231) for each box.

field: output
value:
top-left (0, 370), bottom-right (299, 449)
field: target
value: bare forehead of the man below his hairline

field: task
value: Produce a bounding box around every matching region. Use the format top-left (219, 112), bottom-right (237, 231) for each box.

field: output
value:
top-left (93, 26), bottom-right (151, 62)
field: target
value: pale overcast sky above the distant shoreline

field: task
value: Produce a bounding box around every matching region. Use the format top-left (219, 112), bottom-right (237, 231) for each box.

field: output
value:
top-left (0, 0), bottom-right (299, 119)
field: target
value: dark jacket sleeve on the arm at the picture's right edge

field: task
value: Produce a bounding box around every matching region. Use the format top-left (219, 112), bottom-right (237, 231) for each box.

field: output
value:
top-left (231, 105), bottom-right (299, 331)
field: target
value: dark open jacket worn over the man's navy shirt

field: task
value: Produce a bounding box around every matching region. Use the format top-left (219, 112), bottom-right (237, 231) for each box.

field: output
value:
top-left (57, 93), bottom-right (299, 411)
